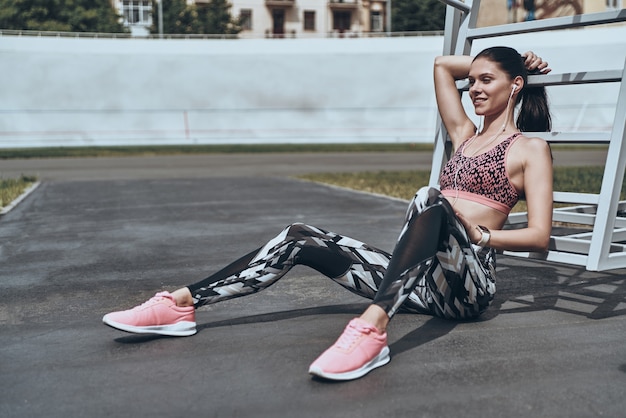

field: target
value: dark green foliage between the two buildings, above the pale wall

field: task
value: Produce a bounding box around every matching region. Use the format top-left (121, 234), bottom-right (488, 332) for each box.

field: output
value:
top-left (150, 0), bottom-right (241, 35)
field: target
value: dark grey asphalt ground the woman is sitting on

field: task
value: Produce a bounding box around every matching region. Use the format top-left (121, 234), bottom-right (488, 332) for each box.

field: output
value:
top-left (0, 154), bottom-right (626, 418)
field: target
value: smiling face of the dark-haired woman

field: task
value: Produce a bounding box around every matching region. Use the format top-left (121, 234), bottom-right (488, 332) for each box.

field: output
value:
top-left (468, 58), bottom-right (519, 116)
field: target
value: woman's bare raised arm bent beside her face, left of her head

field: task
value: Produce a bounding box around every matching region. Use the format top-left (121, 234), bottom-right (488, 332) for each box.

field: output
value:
top-left (433, 55), bottom-right (476, 149)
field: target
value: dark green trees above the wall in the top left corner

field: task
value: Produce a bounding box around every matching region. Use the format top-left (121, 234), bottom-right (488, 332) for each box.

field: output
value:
top-left (0, 0), bottom-right (126, 33)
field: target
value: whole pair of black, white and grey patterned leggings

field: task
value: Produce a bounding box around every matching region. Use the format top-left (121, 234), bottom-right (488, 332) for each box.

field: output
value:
top-left (188, 187), bottom-right (495, 319)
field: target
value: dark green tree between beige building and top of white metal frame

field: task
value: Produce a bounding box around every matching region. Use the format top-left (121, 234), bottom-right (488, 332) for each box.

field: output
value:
top-left (391, 0), bottom-right (446, 32)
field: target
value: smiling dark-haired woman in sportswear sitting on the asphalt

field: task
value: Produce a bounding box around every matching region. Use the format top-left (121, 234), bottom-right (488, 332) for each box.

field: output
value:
top-left (103, 47), bottom-right (552, 380)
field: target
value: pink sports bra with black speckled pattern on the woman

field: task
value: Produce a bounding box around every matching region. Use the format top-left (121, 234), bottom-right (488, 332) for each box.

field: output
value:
top-left (439, 132), bottom-right (521, 215)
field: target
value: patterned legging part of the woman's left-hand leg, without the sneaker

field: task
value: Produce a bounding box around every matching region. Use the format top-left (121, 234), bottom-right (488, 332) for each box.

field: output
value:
top-left (187, 223), bottom-right (390, 307)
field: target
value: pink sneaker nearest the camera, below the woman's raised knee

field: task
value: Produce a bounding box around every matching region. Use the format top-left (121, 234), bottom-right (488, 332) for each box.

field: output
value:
top-left (309, 318), bottom-right (389, 380)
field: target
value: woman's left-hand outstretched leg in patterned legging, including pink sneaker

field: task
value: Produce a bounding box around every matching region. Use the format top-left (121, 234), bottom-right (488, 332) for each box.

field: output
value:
top-left (103, 224), bottom-right (390, 336)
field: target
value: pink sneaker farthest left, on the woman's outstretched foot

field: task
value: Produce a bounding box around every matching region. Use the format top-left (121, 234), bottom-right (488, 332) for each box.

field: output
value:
top-left (102, 292), bottom-right (196, 337)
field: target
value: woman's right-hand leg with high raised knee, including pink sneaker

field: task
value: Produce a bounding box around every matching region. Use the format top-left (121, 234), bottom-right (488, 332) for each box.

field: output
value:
top-left (309, 188), bottom-right (495, 380)
